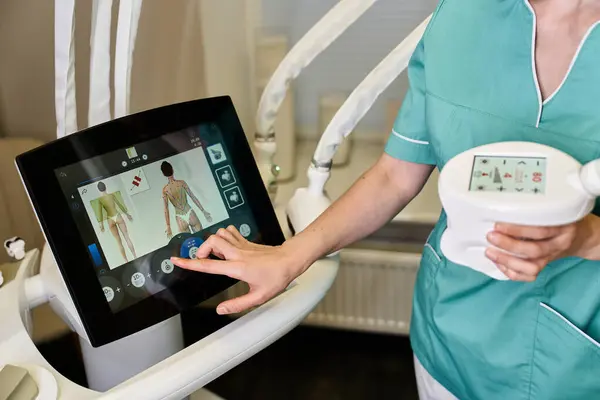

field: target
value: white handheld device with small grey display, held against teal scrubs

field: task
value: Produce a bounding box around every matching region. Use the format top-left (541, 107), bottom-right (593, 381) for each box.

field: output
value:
top-left (438, 142), bottom-right (600, 280)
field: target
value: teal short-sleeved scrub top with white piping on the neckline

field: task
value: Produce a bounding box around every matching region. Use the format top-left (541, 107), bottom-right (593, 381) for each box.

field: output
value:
top-left (386, 0), bottom-right (600, 400)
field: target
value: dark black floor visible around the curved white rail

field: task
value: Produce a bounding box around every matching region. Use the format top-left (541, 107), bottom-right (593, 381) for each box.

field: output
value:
top-left (39, 309), bottom-right (418, 400)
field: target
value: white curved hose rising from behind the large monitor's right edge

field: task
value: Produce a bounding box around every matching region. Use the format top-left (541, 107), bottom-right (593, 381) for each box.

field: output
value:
top-left (254, 0), bottom-right (377, 191)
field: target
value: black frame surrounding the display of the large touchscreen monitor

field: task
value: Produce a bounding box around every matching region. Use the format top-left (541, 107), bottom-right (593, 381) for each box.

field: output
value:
top-left (16, 96), bottom-right (284, 347)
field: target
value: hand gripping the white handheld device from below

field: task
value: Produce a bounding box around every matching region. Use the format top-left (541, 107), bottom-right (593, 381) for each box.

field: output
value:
top-left (486, 215), bottom-right (600, 282)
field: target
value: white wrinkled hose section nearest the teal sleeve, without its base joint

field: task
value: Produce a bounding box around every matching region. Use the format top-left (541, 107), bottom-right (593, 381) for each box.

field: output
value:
top-left (313, 16), bottom-right (431, 169)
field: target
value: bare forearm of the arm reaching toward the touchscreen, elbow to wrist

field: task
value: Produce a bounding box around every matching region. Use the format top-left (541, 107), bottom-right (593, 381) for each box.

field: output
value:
top-left (284, 154), bottom-right (433, 273)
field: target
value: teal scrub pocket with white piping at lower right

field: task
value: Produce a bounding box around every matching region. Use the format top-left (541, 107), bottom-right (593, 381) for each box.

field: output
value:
top-left (529, 303), bottom-right (600, 400)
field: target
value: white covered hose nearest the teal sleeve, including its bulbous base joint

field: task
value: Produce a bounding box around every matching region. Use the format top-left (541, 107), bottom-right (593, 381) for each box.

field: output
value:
top-left (286, 16), bottom-right (431, 233)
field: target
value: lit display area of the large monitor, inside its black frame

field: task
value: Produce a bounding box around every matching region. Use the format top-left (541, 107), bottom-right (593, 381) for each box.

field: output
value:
top-left (54, 123), bottom-right (257, 312)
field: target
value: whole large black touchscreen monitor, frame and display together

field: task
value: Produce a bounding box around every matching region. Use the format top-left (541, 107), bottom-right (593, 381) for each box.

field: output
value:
top-left (17, 97), bottom-right (283, 345)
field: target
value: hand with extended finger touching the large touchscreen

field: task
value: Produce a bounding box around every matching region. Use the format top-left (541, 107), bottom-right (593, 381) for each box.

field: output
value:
top-left (171, 226), bottom-right (303, 314)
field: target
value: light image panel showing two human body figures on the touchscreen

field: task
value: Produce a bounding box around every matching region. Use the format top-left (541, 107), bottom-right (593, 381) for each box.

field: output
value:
top-left (78, 144), bottom-right (229, 269)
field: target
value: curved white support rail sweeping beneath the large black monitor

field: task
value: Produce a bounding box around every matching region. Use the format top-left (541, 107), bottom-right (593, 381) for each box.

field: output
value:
top-left (0, 251), bottom-right (339, 400)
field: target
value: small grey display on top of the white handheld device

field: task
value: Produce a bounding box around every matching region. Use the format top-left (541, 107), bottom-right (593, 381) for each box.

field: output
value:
top-left (469, 156), bottom-right (546, 194)
